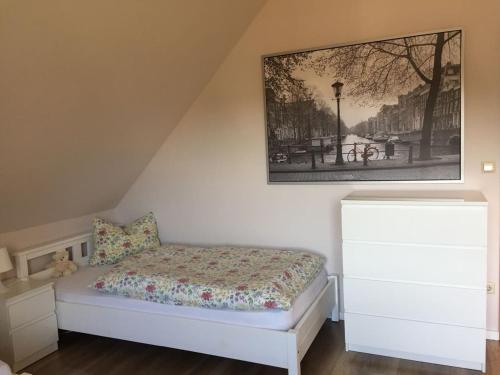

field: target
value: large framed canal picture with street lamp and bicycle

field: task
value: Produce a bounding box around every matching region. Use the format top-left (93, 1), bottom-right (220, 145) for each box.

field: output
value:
top-left (263, 29), bottom-right (463, 183)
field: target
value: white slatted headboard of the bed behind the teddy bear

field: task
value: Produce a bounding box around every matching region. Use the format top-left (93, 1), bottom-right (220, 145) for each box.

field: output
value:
top-left (14, 233), bottom-right (93, 280)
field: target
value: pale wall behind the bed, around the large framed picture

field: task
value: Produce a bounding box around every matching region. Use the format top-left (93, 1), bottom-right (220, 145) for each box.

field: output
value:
top-left (115, 0), bottom-right (500, 330)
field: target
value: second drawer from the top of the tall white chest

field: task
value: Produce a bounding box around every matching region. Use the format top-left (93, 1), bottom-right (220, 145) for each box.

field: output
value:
top-left (342, 240), bottom-right (487, 288)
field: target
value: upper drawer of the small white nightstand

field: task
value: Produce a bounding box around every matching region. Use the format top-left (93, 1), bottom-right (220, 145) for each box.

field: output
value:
top-left (9, 288), bottom-right (55, 329)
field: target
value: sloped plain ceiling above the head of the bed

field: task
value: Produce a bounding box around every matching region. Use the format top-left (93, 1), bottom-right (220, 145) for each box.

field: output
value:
top-left (0, 0), bottom-right (265, 233)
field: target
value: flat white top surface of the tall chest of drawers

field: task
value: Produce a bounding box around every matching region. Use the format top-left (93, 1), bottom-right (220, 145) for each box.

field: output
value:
top-left (342, 190), bottom-right (488, 206)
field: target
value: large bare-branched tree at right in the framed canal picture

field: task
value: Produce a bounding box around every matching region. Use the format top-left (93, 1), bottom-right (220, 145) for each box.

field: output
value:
top-left (308, 31), bottom-right (461, 160)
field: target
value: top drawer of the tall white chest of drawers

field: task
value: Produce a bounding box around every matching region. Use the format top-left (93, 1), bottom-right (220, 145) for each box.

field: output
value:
top-left (342, 204), bottom-right (486, 247)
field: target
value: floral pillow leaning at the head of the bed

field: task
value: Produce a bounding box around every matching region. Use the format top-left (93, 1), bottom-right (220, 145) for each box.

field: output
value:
top-left (89, 212), bottom-right (160, 266)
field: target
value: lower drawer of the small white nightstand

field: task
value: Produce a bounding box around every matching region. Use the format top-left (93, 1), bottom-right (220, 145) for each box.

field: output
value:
top-left (12, 314), bottom-right (58, 362)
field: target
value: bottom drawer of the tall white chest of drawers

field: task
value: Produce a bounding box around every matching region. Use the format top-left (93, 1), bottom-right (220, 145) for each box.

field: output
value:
top-left (344, 313), bottom-right (486, 367)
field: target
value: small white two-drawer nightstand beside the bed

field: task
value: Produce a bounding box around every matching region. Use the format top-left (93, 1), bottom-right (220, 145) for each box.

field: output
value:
top-left (0, 280), bottom-right (58, 372)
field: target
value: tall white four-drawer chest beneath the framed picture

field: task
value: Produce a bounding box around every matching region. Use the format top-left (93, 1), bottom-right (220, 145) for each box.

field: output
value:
top-left (342, 192), bottom-right (487, 371)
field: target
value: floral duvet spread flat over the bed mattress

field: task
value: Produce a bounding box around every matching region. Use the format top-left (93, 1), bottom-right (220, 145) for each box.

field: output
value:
top-left (90, 245), bottom-right (325, 310)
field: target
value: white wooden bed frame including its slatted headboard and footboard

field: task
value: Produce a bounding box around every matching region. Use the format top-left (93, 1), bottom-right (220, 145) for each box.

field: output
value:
top-left (15, 233), bottom-right (339, 375)
